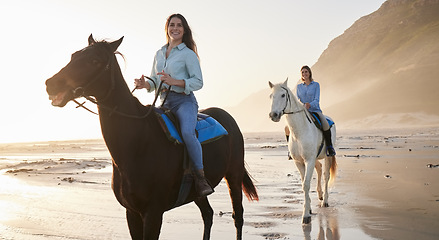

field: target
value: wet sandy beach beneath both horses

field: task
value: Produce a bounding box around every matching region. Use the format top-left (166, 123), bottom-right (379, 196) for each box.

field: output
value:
top-left (0, 128), bottom-right (439, 240)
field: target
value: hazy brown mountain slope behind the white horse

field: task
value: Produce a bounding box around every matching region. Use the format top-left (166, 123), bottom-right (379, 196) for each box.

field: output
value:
top-left (227, 0), bottom-right (439, 131)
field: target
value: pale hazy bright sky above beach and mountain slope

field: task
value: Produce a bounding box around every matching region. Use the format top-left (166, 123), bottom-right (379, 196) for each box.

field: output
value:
top-left (0, 0), bottom-right (385, 142)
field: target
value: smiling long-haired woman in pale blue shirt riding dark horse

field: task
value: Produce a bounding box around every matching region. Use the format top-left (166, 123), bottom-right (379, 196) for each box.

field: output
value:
top-left (135, 14), bottom-right (213, 197)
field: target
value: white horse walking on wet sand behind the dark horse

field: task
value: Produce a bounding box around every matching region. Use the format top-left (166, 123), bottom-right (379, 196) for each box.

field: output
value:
top-left (268, 78), bottom-right (337, 224)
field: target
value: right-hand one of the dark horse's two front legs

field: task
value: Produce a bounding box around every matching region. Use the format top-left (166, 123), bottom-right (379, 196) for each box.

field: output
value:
top-left (143, 207), bottom-right (163, 240)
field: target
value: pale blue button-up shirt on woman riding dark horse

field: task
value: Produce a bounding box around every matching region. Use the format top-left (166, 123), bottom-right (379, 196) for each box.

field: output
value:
top-left (148, 43), bottom-right (203, 95)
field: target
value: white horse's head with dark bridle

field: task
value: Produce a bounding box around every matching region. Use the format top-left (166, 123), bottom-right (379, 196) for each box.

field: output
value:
top-left (268, 78), bottom-right (290, 122)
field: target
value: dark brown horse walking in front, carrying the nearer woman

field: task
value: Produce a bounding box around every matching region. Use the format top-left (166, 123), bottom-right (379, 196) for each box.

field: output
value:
top-left (46, 35), bottom-right (258, 239)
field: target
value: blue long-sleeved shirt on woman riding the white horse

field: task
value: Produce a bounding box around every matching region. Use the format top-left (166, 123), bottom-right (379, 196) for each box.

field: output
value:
top-left (297, 81), bottom-right (322, 112)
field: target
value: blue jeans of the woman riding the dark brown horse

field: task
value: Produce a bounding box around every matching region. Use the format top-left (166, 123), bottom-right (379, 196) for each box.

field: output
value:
top-left (163, 91), bottom-right (203, 170)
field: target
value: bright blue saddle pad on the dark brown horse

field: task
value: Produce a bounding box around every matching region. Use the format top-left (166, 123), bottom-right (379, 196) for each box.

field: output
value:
top-left (155, 108), bottom-right (228, 144)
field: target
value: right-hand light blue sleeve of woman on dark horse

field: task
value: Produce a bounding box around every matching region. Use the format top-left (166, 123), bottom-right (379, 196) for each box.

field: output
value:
top-left (183, 51), bottom-right (203, 94)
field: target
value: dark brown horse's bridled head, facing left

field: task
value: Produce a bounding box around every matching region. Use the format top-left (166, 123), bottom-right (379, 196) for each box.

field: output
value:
top-left (46, 35), bottom-right (123, 107)
